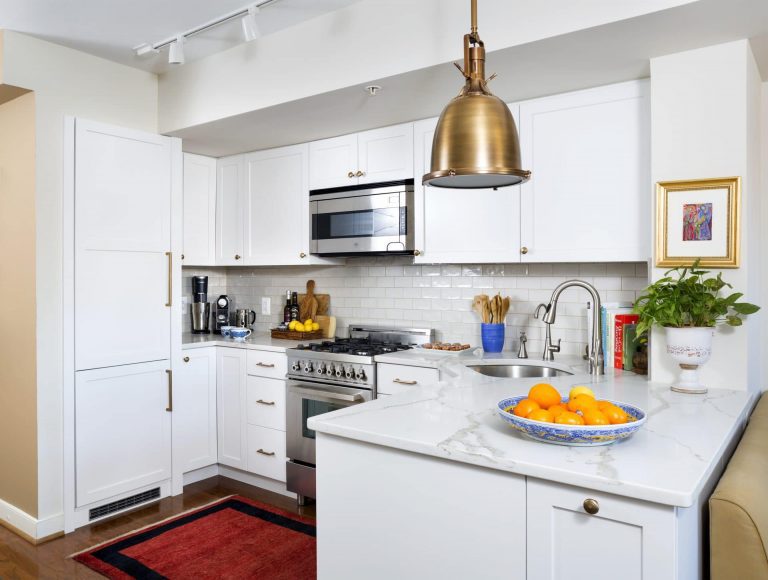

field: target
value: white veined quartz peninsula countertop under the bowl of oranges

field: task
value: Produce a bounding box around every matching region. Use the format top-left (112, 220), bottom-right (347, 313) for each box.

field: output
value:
top-left (308, 362), bottom-right (754, 507)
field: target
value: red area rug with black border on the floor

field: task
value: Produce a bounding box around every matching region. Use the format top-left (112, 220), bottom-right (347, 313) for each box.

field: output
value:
top-left (73, 496), bottom-right (317, 580)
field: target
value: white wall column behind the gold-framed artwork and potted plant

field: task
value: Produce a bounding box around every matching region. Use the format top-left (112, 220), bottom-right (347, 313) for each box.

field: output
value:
top-left (651, 40), bottom-right (768, 389)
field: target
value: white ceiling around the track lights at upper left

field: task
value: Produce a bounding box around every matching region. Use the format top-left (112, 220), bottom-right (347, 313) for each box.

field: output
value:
top-left (0, 0), bottom-right (359, 73)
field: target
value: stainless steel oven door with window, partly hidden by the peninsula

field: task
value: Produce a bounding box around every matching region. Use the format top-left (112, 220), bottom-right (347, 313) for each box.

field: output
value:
top-left (286, 379), bottom-right (373, 465)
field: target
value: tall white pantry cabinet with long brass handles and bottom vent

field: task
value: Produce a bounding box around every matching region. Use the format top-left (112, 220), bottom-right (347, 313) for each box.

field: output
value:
top-left (64, 119), bottom-right (181, 531)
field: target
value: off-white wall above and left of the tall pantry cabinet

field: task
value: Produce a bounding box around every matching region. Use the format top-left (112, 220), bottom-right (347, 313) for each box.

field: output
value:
top-left (2, 31), bottom-right (157, 531)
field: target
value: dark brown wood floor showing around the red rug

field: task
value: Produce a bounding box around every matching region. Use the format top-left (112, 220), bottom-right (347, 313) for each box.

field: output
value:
top-left (0, 476), bottom-right (315, 580)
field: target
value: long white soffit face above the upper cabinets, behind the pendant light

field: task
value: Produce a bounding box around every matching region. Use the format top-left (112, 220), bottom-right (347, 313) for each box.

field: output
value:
top-left (160, 0), bottom-right (692, 133)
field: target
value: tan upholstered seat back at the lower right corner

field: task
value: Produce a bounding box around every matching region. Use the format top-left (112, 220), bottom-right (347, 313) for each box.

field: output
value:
top-left (709, 394), bottom-right (768, 580)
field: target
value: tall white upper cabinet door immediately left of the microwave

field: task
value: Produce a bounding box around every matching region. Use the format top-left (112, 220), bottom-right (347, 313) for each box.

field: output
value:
top-left (244, 144), bottom-right (309, 266)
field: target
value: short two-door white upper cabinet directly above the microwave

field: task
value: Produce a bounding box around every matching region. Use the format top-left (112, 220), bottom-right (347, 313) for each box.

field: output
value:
top-left (309, 123), bottom-right (413, 189)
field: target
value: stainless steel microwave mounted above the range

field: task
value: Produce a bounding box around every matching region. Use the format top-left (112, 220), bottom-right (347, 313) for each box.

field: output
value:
top-left (309, 179), bottom-right (414, 256)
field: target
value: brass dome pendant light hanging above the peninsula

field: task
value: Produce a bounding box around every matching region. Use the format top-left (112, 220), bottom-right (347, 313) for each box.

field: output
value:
top-left (422, 0), bottom-right (531, 189)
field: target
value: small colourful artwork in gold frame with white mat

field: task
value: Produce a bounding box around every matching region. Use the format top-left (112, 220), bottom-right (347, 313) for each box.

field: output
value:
top-left (656, 177), bottom-right (741, 268)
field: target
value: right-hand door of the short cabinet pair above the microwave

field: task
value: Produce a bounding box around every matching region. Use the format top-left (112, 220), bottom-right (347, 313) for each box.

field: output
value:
top-left (357, 123), bottom-right (413, 183)
